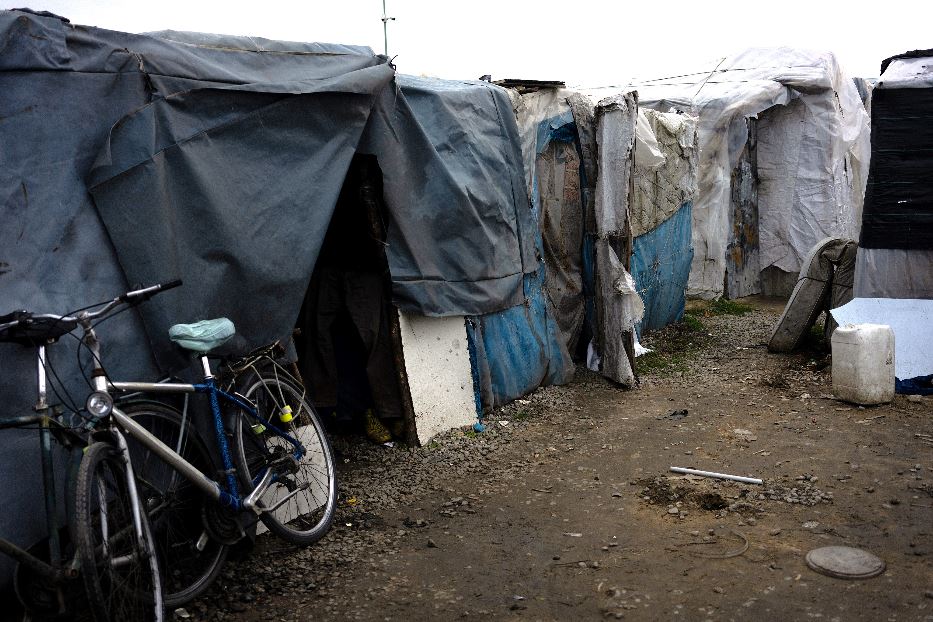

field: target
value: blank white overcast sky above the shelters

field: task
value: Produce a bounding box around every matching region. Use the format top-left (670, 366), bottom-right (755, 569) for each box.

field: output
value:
top-left (0, 0), bottom-right (933, 86)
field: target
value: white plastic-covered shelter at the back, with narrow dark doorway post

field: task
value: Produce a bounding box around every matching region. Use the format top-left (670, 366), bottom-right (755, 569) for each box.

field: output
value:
top-left (604, 48), bottom-right (869, 298)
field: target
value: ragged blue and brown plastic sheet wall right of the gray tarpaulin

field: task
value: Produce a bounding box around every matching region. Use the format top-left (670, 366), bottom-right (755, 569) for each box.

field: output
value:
top-left (467, 90), bottom-right (584, 410)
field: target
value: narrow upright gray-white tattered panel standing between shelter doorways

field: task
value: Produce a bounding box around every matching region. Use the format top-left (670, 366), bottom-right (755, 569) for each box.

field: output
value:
top-left (594, 92), bottom-right (644, 386)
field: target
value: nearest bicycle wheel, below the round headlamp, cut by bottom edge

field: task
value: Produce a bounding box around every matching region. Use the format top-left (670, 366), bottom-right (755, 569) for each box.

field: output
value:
top-left (74, 443), bottom-right (163, 622)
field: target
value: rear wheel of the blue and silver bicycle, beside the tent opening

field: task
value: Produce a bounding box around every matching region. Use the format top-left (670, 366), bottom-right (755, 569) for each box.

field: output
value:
top-left (234, 367), bottom-right (337, 546)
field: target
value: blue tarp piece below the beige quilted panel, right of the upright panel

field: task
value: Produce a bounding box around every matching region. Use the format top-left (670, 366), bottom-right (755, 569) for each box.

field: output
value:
top-left (631, 202), bottom-right (693, 335)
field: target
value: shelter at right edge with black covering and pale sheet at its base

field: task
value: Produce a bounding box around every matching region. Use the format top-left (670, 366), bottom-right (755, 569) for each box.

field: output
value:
top-left (832, 50), bottom-right (933, 395)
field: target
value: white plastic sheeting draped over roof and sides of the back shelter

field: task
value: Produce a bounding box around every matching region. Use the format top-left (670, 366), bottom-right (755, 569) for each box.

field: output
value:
top-left (588, 48), bottom-right (869, 298)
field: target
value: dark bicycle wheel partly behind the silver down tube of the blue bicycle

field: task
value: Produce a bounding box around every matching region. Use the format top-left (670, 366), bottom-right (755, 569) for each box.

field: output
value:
top-left (123, 402), bottom-right (229, 609)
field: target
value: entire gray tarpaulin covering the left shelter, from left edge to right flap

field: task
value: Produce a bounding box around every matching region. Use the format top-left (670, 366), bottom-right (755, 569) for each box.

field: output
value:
top-left (0, 11), bottom-right (537, 584)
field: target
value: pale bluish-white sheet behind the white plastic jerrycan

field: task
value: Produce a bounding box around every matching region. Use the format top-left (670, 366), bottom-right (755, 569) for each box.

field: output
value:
top-left (831, 298), bottom-right (933, 388)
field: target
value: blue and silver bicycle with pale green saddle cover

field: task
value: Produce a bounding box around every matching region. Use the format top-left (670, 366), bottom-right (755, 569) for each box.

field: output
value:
top-left (70, 281), bottom-right (336, 616)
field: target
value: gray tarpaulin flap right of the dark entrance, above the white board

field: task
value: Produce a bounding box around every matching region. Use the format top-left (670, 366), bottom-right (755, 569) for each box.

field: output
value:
top-left (378, 75), bottom-right (538, 316)
